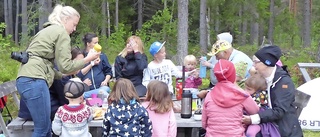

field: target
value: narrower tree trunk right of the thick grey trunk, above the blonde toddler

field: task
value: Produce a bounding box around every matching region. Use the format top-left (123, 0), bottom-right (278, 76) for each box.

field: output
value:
top-left (199, 0), bottom-right (208, 54)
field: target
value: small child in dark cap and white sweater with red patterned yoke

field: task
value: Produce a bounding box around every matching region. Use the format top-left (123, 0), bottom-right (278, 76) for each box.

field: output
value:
top-left (52, 78), bottom-right (93, 137)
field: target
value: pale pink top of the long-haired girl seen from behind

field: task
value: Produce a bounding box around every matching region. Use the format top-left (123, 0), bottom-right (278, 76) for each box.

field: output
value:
top-left (142, 101), bottom-right (177, 137)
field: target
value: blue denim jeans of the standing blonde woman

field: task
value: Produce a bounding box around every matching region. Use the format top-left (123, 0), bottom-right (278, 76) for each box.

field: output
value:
top-left (16, 77), bottom-right (51, 137)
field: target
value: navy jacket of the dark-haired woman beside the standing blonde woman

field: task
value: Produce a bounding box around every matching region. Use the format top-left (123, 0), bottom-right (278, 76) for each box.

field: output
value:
top-left (77, 53), bottom-right (112, 90)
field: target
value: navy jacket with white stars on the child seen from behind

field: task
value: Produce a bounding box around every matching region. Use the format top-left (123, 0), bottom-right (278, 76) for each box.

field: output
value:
top-left (103, 100), bottom-right (152, 137)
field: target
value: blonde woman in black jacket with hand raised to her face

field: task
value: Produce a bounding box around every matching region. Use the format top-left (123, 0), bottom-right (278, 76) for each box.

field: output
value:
top-left (114, 36), bottom-right (148, 97)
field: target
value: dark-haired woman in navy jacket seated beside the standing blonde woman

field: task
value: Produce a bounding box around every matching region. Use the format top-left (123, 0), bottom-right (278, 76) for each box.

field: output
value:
top-left (77, 33), bottom-right (112, 98)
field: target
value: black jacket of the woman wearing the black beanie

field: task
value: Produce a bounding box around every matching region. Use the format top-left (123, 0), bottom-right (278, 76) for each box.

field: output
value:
top-left (259, 66), bottom-right (303, 137)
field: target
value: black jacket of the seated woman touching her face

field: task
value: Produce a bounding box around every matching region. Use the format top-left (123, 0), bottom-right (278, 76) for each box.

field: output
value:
top-left (114, 52), bottom-right (148, 86)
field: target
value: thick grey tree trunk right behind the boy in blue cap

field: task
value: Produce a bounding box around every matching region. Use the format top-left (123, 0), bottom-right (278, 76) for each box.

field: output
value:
top-left (177, 0), bottom-right (189, 65)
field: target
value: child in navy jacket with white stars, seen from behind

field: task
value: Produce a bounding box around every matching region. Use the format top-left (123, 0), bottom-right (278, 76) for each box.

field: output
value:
top-left (102, 78), bottom-right (152, 137)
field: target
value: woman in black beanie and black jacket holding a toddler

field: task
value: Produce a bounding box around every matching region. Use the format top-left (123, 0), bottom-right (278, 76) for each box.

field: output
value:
top-left (243, 46), bottom-right (303, 137)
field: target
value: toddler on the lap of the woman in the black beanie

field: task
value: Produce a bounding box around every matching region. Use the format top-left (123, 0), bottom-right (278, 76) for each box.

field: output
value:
top-left (245, 73), bottom-right (280, 137)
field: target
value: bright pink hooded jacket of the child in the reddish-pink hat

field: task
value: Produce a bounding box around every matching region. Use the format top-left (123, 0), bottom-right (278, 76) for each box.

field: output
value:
top-left (202, 82), bottom-right (259, 137)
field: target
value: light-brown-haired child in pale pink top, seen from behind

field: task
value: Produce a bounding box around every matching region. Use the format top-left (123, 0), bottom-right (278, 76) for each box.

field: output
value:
top-left (142, 80), bottom-right (177, 137)
